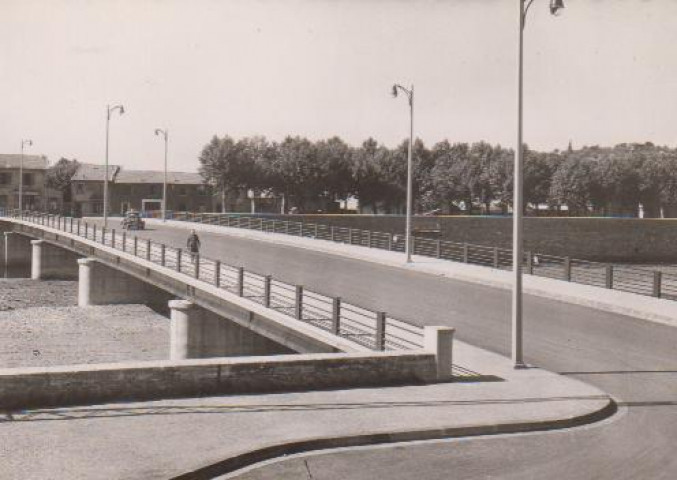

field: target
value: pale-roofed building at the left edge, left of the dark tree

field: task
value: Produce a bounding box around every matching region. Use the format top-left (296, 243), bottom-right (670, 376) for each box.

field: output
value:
top-left (0, 154), bottom-right (59, 210)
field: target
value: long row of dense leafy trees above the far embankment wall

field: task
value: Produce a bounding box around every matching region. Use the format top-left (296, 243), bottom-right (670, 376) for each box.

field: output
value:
top-left (199, 136), bottom-right (677, 216)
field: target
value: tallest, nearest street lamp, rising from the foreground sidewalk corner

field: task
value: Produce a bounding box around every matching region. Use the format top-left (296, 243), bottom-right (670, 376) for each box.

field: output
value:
top-left (512, 0), bottom-right (564, 368)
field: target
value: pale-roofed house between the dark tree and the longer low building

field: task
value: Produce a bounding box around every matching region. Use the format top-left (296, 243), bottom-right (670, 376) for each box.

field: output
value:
top-left (71, 163), bottom-right (120, 217)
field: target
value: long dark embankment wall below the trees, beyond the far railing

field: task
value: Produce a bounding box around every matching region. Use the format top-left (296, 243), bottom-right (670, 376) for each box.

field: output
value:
top-left (251, 215), bottom-right (677, 263)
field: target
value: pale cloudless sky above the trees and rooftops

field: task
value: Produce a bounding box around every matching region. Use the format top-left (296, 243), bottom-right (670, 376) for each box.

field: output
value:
top-left (0, 0), bottom-right (677, 171)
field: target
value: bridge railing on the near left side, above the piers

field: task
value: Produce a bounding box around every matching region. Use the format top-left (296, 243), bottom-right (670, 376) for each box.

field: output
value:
top-left (9, 211), bottom-right (428, 354)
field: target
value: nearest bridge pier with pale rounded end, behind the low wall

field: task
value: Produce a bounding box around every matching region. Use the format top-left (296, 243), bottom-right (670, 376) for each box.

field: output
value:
top-left (169, 300), bottom-right (297, 360)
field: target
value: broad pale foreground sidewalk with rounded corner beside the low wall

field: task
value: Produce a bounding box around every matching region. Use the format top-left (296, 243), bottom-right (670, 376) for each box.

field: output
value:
top-left (0, 342), bottom-right (615, 479)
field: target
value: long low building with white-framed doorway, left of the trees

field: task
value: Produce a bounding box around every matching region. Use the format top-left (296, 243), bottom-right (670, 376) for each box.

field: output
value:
top-left (110, 168), bottom-right (214, 215)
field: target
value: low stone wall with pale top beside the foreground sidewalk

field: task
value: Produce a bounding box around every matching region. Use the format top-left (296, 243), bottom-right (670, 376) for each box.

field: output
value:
top-left (0, 353), bottom-right (436, 410)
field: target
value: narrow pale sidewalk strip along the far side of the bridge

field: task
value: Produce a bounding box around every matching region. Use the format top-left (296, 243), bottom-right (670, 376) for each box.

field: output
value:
top-left (147, 219), bottom-right (677, 326)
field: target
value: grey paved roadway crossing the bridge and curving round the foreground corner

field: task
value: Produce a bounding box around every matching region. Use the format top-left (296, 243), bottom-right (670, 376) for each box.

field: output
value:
top-left (101, 221), bottom-right (677, 480)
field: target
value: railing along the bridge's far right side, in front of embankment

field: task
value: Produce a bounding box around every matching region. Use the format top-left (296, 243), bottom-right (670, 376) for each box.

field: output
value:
top-left (162, 212), bottom-right (677, 300)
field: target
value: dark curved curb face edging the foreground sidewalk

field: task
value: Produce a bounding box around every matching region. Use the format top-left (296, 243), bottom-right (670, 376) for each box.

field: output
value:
top-left (170, 397), bottom-right (618, 480)
